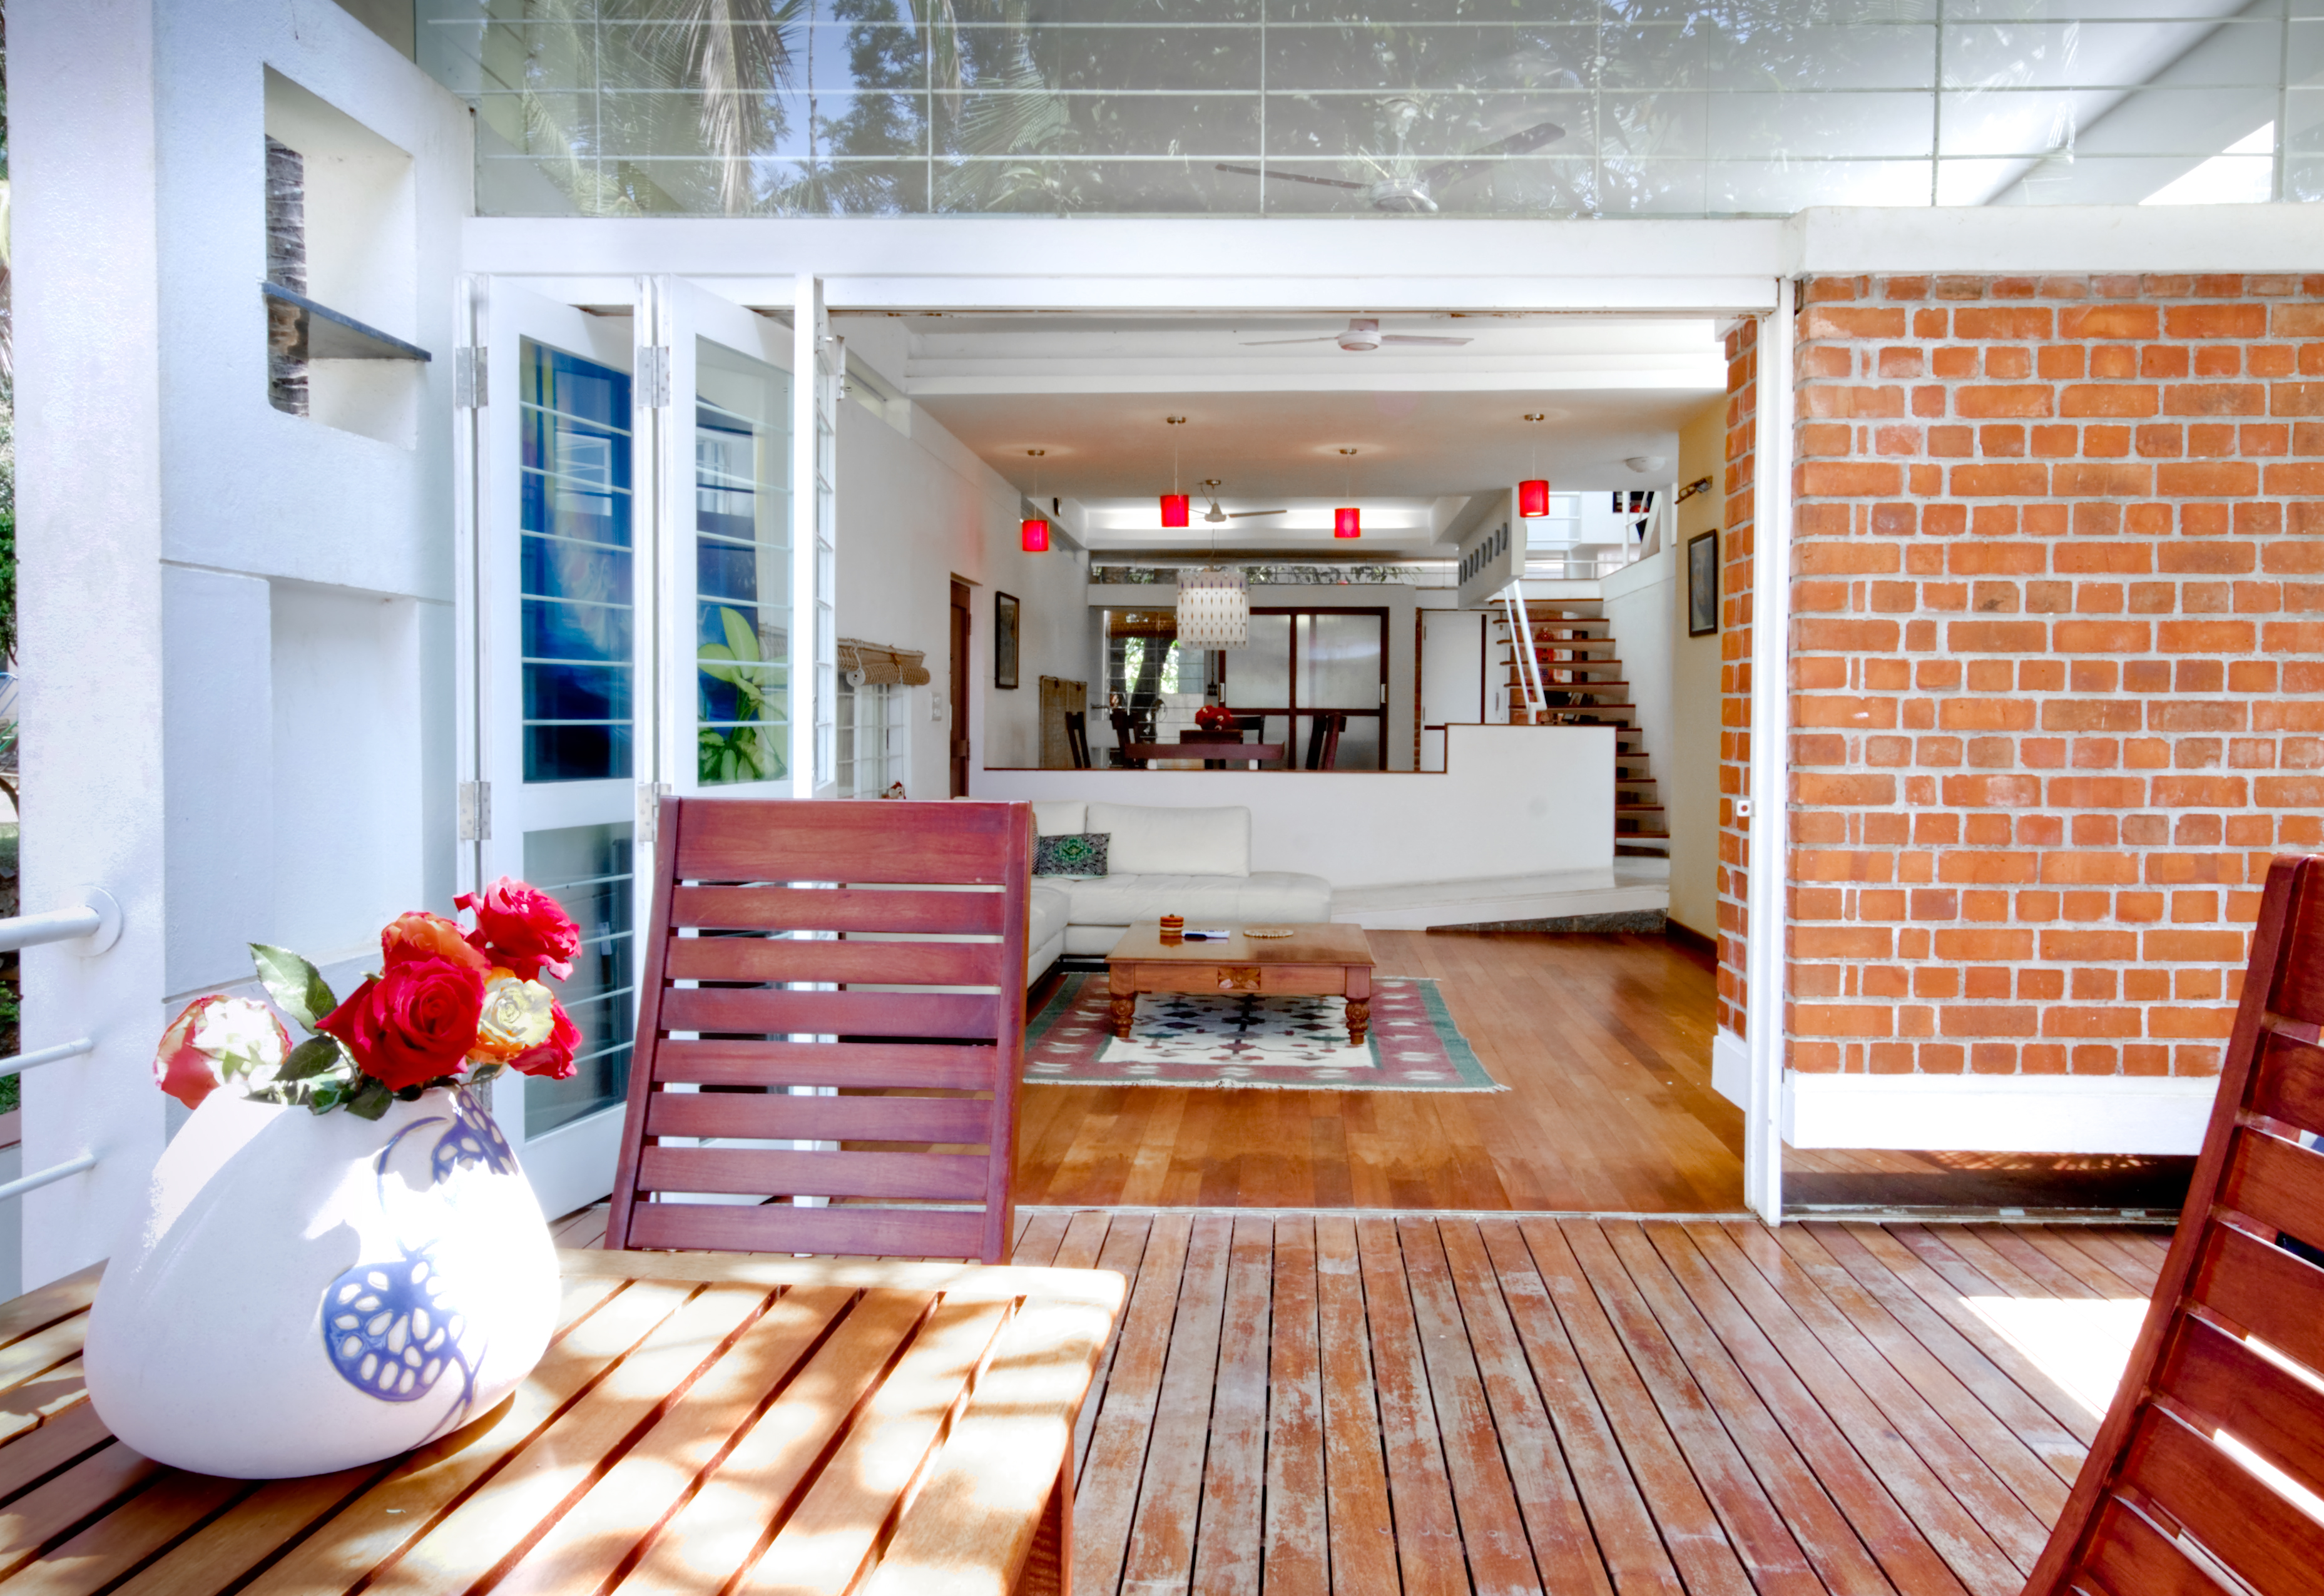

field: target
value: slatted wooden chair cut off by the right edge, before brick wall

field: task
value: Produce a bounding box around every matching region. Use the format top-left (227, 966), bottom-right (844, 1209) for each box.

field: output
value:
top-left (2027, 855), bottom-right (2324, 1596)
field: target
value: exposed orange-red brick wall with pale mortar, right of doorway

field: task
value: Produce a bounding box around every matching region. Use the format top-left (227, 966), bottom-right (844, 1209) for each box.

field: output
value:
top-left (1722, 277), bottom-right (2324, 1075)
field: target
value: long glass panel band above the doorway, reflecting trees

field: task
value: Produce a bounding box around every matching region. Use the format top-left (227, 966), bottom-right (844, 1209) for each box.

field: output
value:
top-left (416, 0), bottom-right (2324, 216)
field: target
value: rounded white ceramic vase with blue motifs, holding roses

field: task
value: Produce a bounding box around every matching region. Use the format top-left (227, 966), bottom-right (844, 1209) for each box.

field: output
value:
top-left (84, 1087), bottom-right (558, 1480)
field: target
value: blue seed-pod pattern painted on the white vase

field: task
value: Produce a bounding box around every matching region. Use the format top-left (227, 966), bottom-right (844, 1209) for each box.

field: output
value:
top-left (323, 1087), bottom-right (516, 1438)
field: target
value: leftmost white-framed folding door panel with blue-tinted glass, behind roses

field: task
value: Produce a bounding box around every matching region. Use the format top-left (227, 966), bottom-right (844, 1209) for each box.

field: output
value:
top-left (460, 279), bottom-right (658, 1215)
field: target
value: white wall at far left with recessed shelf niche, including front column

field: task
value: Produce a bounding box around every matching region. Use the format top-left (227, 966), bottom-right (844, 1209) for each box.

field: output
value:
top-left (9, 0), bottom-right (469, 1284)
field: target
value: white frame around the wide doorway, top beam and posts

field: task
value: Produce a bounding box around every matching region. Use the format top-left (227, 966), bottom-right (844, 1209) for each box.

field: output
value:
top-left (462, 218), bottom-right (1794, 1222)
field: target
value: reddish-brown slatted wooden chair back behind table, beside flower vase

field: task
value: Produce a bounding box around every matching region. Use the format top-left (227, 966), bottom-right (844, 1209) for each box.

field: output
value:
top-left (604, 797), bottom-right (1032, 1264)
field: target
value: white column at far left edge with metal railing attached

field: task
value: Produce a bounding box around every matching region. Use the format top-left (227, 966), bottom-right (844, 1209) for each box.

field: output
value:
top-left (7, 0), bottom-right (171, 1287)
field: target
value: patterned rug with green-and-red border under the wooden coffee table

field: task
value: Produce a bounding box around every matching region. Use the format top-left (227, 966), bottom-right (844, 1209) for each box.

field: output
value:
top-left (1025, 976), bottom-right (1508, 1092)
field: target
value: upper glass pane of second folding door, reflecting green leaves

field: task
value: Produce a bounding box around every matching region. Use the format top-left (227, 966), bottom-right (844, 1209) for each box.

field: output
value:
top-left (695, 339), bottom-right (792, 785)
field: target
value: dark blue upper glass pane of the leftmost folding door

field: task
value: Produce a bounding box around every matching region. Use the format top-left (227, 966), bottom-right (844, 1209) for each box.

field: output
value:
top-left (518, 339), bottom-right (637, 781)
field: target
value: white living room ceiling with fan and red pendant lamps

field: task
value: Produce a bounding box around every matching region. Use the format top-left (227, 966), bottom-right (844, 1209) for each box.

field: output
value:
top-left (902, 312), bottom-right (1727, 557)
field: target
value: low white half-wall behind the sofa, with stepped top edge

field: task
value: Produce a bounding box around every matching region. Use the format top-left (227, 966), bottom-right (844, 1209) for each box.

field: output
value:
top-left (976, 725), bottom-right (1613, 887)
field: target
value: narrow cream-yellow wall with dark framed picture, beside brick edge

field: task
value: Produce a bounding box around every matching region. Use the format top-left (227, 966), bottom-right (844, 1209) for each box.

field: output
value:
top-left (1654, 400), bottom-right (1727, 936)
